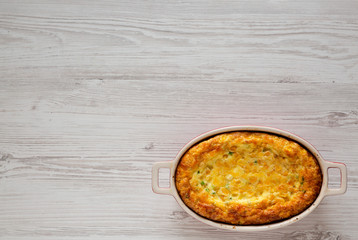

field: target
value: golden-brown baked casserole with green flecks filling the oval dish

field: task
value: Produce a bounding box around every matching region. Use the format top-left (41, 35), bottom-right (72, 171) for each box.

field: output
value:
top-left (175, 132), bottom-right (322, 225)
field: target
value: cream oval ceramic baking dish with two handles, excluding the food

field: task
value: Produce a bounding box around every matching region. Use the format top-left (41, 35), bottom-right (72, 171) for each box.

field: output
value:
top-left (152, 126), bottom-right (347, 232)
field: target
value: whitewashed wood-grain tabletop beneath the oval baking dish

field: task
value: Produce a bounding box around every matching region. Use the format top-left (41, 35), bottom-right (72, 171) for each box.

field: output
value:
top-left (0, 0), bottom-right (358, 240)
